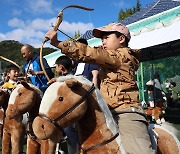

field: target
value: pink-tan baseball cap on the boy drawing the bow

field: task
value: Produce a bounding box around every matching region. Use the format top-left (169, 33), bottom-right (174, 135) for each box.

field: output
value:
top-left (93, 23), bottom-right (131, 40)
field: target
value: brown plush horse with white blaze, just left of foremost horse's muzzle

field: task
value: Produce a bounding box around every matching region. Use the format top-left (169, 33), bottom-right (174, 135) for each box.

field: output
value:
top-left (2, 81), bottom-right (55, 154)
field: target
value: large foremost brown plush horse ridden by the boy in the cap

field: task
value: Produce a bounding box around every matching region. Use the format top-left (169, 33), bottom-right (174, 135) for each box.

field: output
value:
top-left (33, 76), bottom-right (179, 154)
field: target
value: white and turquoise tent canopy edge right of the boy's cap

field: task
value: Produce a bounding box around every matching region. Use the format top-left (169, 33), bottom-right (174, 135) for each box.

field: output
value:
top-left (128, 6), bottom-right (180, 49)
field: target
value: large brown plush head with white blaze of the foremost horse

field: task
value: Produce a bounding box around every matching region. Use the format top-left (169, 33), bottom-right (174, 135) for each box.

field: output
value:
top-left (33, 76), bottom-right (91, 140)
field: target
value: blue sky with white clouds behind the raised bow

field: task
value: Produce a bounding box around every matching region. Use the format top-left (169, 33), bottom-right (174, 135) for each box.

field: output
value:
top-left (0, 0), bottom-right (155, 48)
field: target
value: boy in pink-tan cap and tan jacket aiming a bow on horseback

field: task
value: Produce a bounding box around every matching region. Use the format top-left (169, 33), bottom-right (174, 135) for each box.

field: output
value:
top-left (46, 23), bottom-right (155, 154)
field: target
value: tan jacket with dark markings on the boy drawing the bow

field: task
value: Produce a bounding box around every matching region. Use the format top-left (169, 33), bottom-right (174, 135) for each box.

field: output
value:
top-left (62, 41), bottom-right (140, 111)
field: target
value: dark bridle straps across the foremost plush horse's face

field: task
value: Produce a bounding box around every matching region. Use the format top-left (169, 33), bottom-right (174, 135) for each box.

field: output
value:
top-left (39, 84), bottom-right (95, 130)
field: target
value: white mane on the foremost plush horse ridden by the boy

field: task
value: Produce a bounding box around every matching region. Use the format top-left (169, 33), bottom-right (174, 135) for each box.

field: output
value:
top-left (57, 75), bottom-right (125, 153)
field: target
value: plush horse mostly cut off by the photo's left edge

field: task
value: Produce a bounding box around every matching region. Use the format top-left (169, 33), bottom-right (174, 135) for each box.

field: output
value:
top-left (0, 87), bottom-right (10, 137)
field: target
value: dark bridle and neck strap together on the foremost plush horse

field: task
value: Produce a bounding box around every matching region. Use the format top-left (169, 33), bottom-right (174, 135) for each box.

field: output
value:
top-left (39, 84), bottom-right (119, 154)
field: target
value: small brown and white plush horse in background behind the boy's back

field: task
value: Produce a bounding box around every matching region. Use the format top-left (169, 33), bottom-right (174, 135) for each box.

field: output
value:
top-left (144, 100), bottom-right (166, 124)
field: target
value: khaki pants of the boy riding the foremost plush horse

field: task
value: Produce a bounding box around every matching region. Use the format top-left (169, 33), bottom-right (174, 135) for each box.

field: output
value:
top-left (113, 108), bottom-right (155, 154)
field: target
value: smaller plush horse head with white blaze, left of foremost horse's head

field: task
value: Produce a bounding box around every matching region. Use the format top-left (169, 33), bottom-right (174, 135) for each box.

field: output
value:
top-left (6, 81), bottom-right (41, 119)
